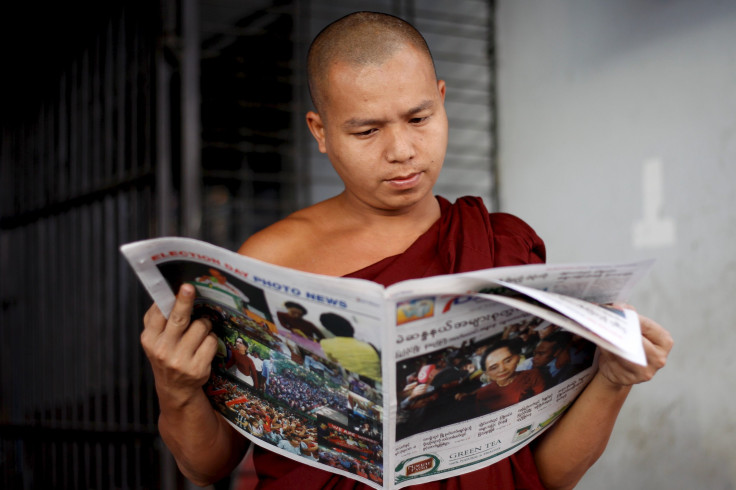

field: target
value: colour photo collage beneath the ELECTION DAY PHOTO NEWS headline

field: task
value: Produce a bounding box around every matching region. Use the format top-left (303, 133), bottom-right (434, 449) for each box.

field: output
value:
top-left (157, 260), bottom-right (383, 484)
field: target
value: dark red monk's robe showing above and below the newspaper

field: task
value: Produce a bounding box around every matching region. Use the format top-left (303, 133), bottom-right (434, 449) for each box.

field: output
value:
top-left (253, 197), bottom-right (545, 490)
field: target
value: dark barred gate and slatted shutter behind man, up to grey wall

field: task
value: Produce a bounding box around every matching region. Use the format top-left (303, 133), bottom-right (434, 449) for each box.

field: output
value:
top-left (0, 0), bottom-right (493, 489)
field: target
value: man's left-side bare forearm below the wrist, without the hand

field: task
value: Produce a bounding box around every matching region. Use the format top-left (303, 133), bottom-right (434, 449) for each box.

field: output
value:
top-left (159, 391), bottom-right (247, 485)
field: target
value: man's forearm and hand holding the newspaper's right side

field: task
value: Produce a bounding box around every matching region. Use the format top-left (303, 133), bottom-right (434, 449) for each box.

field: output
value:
top-left (534, 316), bottom-right (673, 489)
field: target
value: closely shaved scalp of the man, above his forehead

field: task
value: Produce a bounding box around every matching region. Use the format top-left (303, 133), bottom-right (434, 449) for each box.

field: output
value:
top-left (307, 12), bottom-right (434, 117)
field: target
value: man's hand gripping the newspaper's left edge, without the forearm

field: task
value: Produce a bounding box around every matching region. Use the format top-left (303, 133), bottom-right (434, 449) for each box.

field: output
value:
top-left (141, 284), bottom-right (217, 408)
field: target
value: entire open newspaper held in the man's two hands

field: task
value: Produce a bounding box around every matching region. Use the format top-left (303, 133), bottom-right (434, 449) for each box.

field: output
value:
top-left (121, 238), bottom-right (651, 488)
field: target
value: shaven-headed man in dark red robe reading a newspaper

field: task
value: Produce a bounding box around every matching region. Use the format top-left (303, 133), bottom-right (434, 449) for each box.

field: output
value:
top-left (141, 9), bottom-right (672, 490)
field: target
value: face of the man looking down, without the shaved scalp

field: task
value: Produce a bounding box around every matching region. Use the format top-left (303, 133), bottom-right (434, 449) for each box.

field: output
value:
top-left (307, 46), bottom-right (447, 212)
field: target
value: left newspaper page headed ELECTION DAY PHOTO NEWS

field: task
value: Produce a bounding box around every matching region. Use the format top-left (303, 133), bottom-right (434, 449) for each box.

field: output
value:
top-left (121, 238), bottom-right (388, 488)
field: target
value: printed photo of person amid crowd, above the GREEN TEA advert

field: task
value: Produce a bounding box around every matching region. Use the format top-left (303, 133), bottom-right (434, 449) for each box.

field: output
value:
top-left (396, 316), bottom-right (595, 440)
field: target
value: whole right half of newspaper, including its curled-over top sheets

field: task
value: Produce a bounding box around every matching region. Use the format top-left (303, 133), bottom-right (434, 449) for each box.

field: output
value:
top-left (380, 262), bottom-right (651, 488)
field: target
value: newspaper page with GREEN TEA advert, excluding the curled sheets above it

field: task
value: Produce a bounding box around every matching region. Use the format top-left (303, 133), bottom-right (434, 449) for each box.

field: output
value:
top-left (392, 290), bottom-right (595, 484)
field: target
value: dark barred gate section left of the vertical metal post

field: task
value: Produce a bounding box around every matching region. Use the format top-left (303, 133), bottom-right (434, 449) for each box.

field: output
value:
top-left (0, 2), bottom-right (171, 488)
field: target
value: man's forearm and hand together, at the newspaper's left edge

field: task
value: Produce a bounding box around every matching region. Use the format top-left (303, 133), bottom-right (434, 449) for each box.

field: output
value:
top-left (141, 284), bottom-right (246, 485)
